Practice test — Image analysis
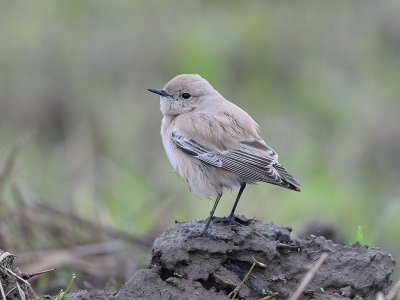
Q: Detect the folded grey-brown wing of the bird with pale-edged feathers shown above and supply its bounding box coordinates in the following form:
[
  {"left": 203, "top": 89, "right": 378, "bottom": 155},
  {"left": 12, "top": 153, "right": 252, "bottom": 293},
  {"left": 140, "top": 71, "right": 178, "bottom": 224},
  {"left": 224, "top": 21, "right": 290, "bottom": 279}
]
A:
[{"left": 171, "top": 130, "right": 300, "bottom": 190}]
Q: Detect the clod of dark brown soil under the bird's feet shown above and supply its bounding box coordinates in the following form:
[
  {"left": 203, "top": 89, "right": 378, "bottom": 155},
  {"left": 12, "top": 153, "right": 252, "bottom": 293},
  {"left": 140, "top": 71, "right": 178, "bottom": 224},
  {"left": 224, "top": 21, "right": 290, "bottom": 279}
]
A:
[{"left": 108, "top": 217, "right": 395, "bottom": 299}]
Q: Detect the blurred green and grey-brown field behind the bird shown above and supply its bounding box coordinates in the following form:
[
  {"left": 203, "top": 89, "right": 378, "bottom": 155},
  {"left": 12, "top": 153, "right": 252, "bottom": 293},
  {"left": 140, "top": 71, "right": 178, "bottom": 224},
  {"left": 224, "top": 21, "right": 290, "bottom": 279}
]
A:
[{"left": 0, "top": 0, "right": 400, "bottom": 288}]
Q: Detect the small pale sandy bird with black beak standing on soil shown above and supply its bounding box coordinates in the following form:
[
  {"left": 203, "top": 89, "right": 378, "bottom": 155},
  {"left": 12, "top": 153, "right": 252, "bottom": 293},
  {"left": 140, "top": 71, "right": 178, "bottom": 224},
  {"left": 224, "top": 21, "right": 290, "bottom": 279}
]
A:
[{"left": 148, "top": 74, "right": 300, "bottom": 234}]
